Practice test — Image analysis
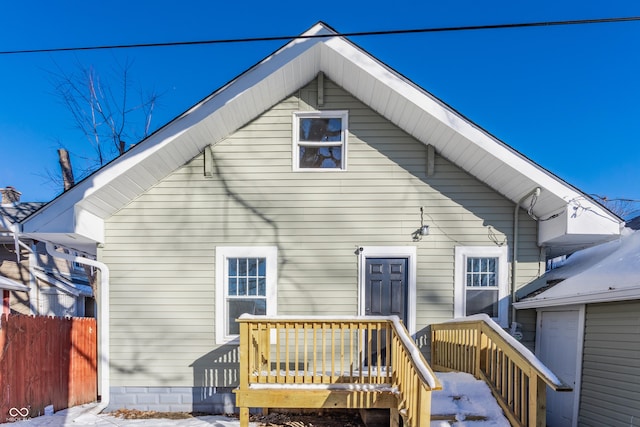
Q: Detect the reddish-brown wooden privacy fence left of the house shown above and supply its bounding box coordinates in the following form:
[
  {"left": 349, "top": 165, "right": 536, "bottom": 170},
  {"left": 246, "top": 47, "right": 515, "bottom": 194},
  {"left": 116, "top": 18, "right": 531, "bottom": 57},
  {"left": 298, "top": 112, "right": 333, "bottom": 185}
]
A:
[{"left": 0, "top": 315, "right": 98, "bottom": 423}]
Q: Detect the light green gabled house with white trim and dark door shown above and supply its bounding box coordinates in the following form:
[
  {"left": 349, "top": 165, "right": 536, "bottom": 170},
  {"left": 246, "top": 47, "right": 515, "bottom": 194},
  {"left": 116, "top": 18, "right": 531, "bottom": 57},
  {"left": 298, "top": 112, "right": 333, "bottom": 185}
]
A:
[{"left": 22, "top": 23, "right": 621, "bottom": 412}]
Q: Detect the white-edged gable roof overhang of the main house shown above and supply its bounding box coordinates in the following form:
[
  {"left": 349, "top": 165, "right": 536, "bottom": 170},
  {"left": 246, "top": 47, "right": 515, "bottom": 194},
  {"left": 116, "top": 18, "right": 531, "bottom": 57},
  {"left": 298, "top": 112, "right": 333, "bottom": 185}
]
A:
[{"left": 23, "top": 23, "right": 621, "bottom": 252}]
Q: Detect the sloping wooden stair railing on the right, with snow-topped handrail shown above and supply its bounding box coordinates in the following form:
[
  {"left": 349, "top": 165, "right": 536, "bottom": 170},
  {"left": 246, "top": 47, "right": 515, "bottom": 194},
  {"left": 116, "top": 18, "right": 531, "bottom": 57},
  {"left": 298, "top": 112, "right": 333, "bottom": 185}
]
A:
[{"left": 431, "top": 315, "right": 571, "bottom": 427}]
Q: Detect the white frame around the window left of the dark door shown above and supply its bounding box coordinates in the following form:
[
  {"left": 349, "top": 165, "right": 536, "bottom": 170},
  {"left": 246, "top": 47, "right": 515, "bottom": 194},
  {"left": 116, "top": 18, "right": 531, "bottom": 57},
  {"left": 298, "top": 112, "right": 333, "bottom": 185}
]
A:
[{"left": 215, "top": 246, "right": 278, "bottom": 344}]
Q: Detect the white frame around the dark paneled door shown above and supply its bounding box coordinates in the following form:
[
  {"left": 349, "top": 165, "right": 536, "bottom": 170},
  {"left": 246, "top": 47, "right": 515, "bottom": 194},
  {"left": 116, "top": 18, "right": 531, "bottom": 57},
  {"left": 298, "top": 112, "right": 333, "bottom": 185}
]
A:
[{"left": 358, "top": 246, "right": 417, "bottom": 335}]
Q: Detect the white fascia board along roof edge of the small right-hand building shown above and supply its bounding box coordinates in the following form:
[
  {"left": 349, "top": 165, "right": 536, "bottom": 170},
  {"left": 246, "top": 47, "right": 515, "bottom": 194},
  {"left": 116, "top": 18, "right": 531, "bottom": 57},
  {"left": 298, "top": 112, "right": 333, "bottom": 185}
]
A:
[{"left": 513, "top": 285, "right": 640, "bottom": 310}]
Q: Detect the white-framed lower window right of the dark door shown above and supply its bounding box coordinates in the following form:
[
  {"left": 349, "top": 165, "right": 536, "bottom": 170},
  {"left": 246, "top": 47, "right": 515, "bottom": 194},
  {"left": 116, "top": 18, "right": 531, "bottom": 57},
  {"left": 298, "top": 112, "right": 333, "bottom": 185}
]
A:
[{"left": 454, "top": 246, "right": 509, "bottom": 328}]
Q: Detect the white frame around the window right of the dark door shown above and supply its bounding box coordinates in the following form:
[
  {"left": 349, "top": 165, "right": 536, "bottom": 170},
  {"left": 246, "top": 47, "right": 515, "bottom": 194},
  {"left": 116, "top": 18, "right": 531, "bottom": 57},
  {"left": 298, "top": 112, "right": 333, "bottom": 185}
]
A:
[{"left": 453, "top": 246, "right": 509, "bottom": 328}]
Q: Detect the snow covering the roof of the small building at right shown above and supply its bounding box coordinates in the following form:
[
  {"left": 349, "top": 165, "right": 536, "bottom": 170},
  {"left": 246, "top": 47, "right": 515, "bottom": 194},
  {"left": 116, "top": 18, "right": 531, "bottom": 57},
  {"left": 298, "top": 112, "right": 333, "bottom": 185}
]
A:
[{"left": 514, "top": 228, "right": 640, "bottom": 309}]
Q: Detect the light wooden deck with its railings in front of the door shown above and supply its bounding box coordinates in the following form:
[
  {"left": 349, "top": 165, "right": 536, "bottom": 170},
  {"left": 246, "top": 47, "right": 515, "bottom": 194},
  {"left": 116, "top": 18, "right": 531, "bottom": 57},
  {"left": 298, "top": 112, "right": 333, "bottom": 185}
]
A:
[{"left": 235, "top": 315, "right": 571, "bottom": 427}]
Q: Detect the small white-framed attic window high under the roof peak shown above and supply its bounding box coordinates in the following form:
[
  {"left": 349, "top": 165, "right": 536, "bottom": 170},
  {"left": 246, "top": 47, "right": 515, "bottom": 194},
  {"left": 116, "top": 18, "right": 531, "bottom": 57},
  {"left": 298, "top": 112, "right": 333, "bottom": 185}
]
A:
[{"left": 292, "top": 111, "right": 349, "bottom": 171}]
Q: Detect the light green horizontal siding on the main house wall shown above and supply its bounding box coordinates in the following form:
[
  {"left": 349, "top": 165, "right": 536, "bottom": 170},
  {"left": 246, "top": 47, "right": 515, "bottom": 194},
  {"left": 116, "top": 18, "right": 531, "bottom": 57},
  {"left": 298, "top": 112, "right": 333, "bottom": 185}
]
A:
[{"left": 101, "top": 80, "right": 540, "bottom": 386}]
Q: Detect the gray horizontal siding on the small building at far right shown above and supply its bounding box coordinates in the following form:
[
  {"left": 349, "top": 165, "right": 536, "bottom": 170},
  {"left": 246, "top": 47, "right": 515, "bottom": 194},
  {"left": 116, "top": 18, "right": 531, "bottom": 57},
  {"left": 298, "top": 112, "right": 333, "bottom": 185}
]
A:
[{"left": 578, "top": 301, "right": 640, "bottom": 427}]
